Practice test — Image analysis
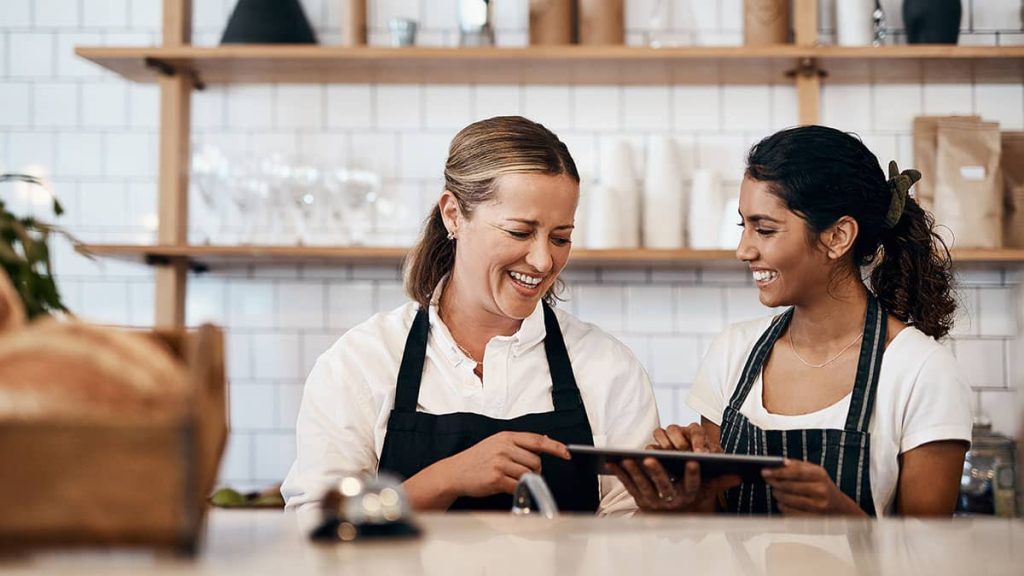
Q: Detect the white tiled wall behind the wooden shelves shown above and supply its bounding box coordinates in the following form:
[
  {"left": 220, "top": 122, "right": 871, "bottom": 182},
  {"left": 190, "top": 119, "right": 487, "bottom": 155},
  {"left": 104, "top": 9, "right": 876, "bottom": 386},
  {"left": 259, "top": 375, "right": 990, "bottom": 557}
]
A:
[{"left": 0, "top": 0, "right": 1024, "bottom": 486}]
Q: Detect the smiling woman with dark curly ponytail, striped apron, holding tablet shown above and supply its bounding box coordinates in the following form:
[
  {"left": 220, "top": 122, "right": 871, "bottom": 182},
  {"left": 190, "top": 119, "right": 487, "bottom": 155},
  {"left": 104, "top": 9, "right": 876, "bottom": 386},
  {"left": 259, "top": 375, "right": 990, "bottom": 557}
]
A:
[{"left": 618, "top": 126, "right": 971, "bottom": 517}]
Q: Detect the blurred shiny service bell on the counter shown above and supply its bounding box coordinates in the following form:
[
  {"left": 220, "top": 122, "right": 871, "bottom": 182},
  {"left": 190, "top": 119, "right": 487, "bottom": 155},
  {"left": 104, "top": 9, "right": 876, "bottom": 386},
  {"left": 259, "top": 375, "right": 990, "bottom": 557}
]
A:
[{"left": 309, "top": 474, "right": 420, "bottom": 542}]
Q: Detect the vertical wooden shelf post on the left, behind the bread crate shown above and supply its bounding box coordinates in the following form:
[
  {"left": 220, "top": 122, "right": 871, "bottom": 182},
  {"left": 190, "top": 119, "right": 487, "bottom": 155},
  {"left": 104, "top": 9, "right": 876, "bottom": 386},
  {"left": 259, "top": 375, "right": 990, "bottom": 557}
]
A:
[{"left": 154, "top": 0, "right": 191, "bottom": 328}]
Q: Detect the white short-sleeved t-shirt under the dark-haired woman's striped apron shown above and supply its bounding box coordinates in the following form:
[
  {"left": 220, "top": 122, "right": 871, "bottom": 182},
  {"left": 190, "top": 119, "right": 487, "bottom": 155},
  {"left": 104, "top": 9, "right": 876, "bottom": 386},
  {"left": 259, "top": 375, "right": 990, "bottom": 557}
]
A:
[{"left": 687, "top": 317, "right": 972, "bottom": 517}]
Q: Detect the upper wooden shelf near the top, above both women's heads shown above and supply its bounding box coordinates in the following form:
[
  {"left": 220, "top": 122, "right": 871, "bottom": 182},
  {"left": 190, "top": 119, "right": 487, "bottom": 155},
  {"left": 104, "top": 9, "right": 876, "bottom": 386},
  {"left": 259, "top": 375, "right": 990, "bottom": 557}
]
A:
[{"left": 75, "top": 45, "right": 1024, "bottom": 85}]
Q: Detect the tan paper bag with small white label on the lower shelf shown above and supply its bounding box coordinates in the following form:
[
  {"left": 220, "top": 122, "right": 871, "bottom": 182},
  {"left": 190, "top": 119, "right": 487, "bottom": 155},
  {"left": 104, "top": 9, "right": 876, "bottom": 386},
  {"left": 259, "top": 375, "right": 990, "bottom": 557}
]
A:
[{"left": 933, "top": 120, "right": 1002, "bottom": 248}]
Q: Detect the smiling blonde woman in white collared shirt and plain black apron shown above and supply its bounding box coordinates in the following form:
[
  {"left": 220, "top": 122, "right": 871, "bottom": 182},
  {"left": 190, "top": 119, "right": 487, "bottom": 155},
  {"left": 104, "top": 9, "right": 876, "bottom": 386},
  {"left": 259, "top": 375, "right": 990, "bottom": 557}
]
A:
[{"left": 282, "top": 117, "right": 658, "bottom": 513}]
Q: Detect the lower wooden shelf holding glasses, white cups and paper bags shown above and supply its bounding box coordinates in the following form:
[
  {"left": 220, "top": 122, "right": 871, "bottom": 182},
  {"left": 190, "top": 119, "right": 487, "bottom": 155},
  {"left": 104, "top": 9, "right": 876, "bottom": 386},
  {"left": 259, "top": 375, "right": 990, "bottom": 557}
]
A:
[{"left": 79, "top": 244, "right": 1024, "bottom": 271}]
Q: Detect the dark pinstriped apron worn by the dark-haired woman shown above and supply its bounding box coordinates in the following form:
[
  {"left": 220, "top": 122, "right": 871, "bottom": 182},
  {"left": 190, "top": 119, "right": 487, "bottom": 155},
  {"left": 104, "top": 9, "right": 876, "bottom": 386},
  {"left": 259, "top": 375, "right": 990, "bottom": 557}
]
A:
[{"left": 721, "top": 293, "right": 887, "bottom": 517}]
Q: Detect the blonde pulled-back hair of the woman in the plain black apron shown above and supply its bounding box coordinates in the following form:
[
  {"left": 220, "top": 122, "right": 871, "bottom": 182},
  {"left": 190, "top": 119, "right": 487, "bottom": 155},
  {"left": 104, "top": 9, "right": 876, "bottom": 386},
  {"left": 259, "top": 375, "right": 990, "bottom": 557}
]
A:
[{"left": 406, "top": 116, "right": 580, "bottom": 308}]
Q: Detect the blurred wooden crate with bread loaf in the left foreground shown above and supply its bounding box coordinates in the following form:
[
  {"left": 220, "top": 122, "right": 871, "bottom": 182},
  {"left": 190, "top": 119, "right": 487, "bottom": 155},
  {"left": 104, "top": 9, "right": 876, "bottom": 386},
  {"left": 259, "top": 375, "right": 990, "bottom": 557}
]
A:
[{"left": 0, "top": 320, "right": 227, "bottom": 553}]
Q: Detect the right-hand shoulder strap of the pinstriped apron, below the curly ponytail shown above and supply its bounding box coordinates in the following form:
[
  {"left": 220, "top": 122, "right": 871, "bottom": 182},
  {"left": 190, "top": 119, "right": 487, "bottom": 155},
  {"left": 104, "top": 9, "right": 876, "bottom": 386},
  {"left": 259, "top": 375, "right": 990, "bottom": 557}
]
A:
[{"left": 846, "top": 292, "right": 888, "bottom": 433}]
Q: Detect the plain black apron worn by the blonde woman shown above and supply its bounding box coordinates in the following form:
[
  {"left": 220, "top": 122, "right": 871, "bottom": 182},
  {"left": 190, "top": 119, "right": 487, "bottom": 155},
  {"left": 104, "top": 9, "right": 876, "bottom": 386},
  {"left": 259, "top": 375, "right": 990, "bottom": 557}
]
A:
[{"left": 379, "top": 303, "right": 599, "bottom": 512}]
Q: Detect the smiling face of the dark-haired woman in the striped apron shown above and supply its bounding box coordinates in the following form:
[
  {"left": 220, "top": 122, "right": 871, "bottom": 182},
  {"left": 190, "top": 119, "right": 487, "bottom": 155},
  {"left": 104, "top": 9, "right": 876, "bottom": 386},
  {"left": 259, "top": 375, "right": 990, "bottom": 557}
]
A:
[{"left": 736, "top": 177, "right": 835, "bottom": 307}]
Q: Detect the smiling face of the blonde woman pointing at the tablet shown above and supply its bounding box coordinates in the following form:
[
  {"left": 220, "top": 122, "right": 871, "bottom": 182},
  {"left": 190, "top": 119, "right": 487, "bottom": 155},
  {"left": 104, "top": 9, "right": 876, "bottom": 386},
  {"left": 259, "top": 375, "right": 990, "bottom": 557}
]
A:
[{"left": 441, "top": 173, "right": 580, "bottom": 321}]
